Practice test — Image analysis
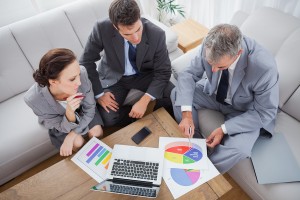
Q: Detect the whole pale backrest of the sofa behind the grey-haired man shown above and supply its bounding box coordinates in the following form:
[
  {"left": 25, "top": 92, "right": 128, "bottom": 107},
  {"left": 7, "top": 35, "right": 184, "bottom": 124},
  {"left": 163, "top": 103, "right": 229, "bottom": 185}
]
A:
[{"left": 237, "top": 7, "right": 300, "bottom": 120}]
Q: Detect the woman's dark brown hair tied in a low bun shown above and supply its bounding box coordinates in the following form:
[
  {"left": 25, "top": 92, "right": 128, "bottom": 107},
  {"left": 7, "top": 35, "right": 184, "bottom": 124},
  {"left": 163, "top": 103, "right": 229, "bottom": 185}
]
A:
[{"left": 33, "top": 48, "right": 76, "bottom": 87}]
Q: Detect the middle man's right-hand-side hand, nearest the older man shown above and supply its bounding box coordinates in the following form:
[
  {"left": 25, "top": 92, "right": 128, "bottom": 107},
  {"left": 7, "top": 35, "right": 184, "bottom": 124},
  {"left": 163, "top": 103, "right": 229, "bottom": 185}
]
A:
[{"left": 129, "top": 94, "right": 151, "bottom": 118}]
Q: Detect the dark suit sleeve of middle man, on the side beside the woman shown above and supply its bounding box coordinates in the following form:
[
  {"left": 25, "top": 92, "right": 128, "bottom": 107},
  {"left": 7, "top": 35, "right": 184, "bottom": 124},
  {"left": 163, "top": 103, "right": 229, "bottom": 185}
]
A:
[{"left": 79, "top": 23, "right": 103, "bottom": 95}]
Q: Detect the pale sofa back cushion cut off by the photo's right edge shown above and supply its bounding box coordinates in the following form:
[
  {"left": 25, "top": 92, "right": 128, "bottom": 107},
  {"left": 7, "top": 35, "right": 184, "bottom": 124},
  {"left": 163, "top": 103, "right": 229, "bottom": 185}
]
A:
[{"left": 276, "top": 28, "right": 300, "bottom": 120}]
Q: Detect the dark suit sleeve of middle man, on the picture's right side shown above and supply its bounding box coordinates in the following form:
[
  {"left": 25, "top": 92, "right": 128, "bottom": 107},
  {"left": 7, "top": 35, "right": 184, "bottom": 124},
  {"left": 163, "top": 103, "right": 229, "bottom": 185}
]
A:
[{"left": 147, "top": 32, "right": 171, "bottom": 98}]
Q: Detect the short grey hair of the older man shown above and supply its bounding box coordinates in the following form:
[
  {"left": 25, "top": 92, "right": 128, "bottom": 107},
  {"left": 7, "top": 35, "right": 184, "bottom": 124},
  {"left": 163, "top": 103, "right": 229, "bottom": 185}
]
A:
[{"left": 203, "top": 24, "right": 243, "bottom": 63}]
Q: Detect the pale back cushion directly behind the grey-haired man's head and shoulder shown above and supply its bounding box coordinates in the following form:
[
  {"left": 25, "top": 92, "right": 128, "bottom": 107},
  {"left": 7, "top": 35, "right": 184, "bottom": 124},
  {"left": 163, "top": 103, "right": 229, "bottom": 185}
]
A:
[{"left": 240, "top": 7, "right": 300, "bottom": 55}]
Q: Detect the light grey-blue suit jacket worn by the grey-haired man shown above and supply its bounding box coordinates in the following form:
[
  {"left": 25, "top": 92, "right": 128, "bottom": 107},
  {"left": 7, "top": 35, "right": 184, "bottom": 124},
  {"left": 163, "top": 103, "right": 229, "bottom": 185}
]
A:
[{"left": 175, "top": 36, "right": 279, "bottom": 134}]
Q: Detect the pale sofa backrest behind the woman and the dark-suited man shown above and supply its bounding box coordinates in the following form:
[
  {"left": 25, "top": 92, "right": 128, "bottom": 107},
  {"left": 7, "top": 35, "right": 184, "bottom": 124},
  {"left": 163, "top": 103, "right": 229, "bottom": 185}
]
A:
[{"left": 0, "top": 0, "right": 178, "bottom": 102}]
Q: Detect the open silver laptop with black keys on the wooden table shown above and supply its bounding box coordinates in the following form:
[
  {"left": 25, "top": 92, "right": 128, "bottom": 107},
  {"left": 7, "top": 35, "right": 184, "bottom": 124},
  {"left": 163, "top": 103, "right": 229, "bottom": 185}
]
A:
[{"left": 91, "top": 144, "right": 164, "bottom": 198}]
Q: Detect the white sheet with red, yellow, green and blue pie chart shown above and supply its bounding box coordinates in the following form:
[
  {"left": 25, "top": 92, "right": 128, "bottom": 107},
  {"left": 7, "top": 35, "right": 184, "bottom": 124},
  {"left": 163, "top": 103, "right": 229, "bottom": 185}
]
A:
[{"left": 159, "top": 137, "right": 208, "bottom": 169}]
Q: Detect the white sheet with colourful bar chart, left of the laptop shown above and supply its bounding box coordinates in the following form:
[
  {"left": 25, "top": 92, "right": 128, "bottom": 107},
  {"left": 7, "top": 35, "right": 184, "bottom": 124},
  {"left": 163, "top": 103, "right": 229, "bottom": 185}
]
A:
[{"left": 72, "top": 137, "right": 112, "bottom": 183}]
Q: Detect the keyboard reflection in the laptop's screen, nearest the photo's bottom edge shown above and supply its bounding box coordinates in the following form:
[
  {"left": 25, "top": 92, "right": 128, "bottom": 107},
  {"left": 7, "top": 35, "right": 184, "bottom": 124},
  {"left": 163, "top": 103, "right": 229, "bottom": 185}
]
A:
[{"left": 110, "top": 184, "right": 156, "bottom": 197}]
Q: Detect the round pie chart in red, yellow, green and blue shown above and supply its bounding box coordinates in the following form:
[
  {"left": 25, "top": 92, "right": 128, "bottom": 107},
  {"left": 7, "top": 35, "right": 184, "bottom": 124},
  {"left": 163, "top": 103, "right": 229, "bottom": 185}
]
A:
[{"left": 164, "top": 142, "right": 203, "bottom": 164}]
